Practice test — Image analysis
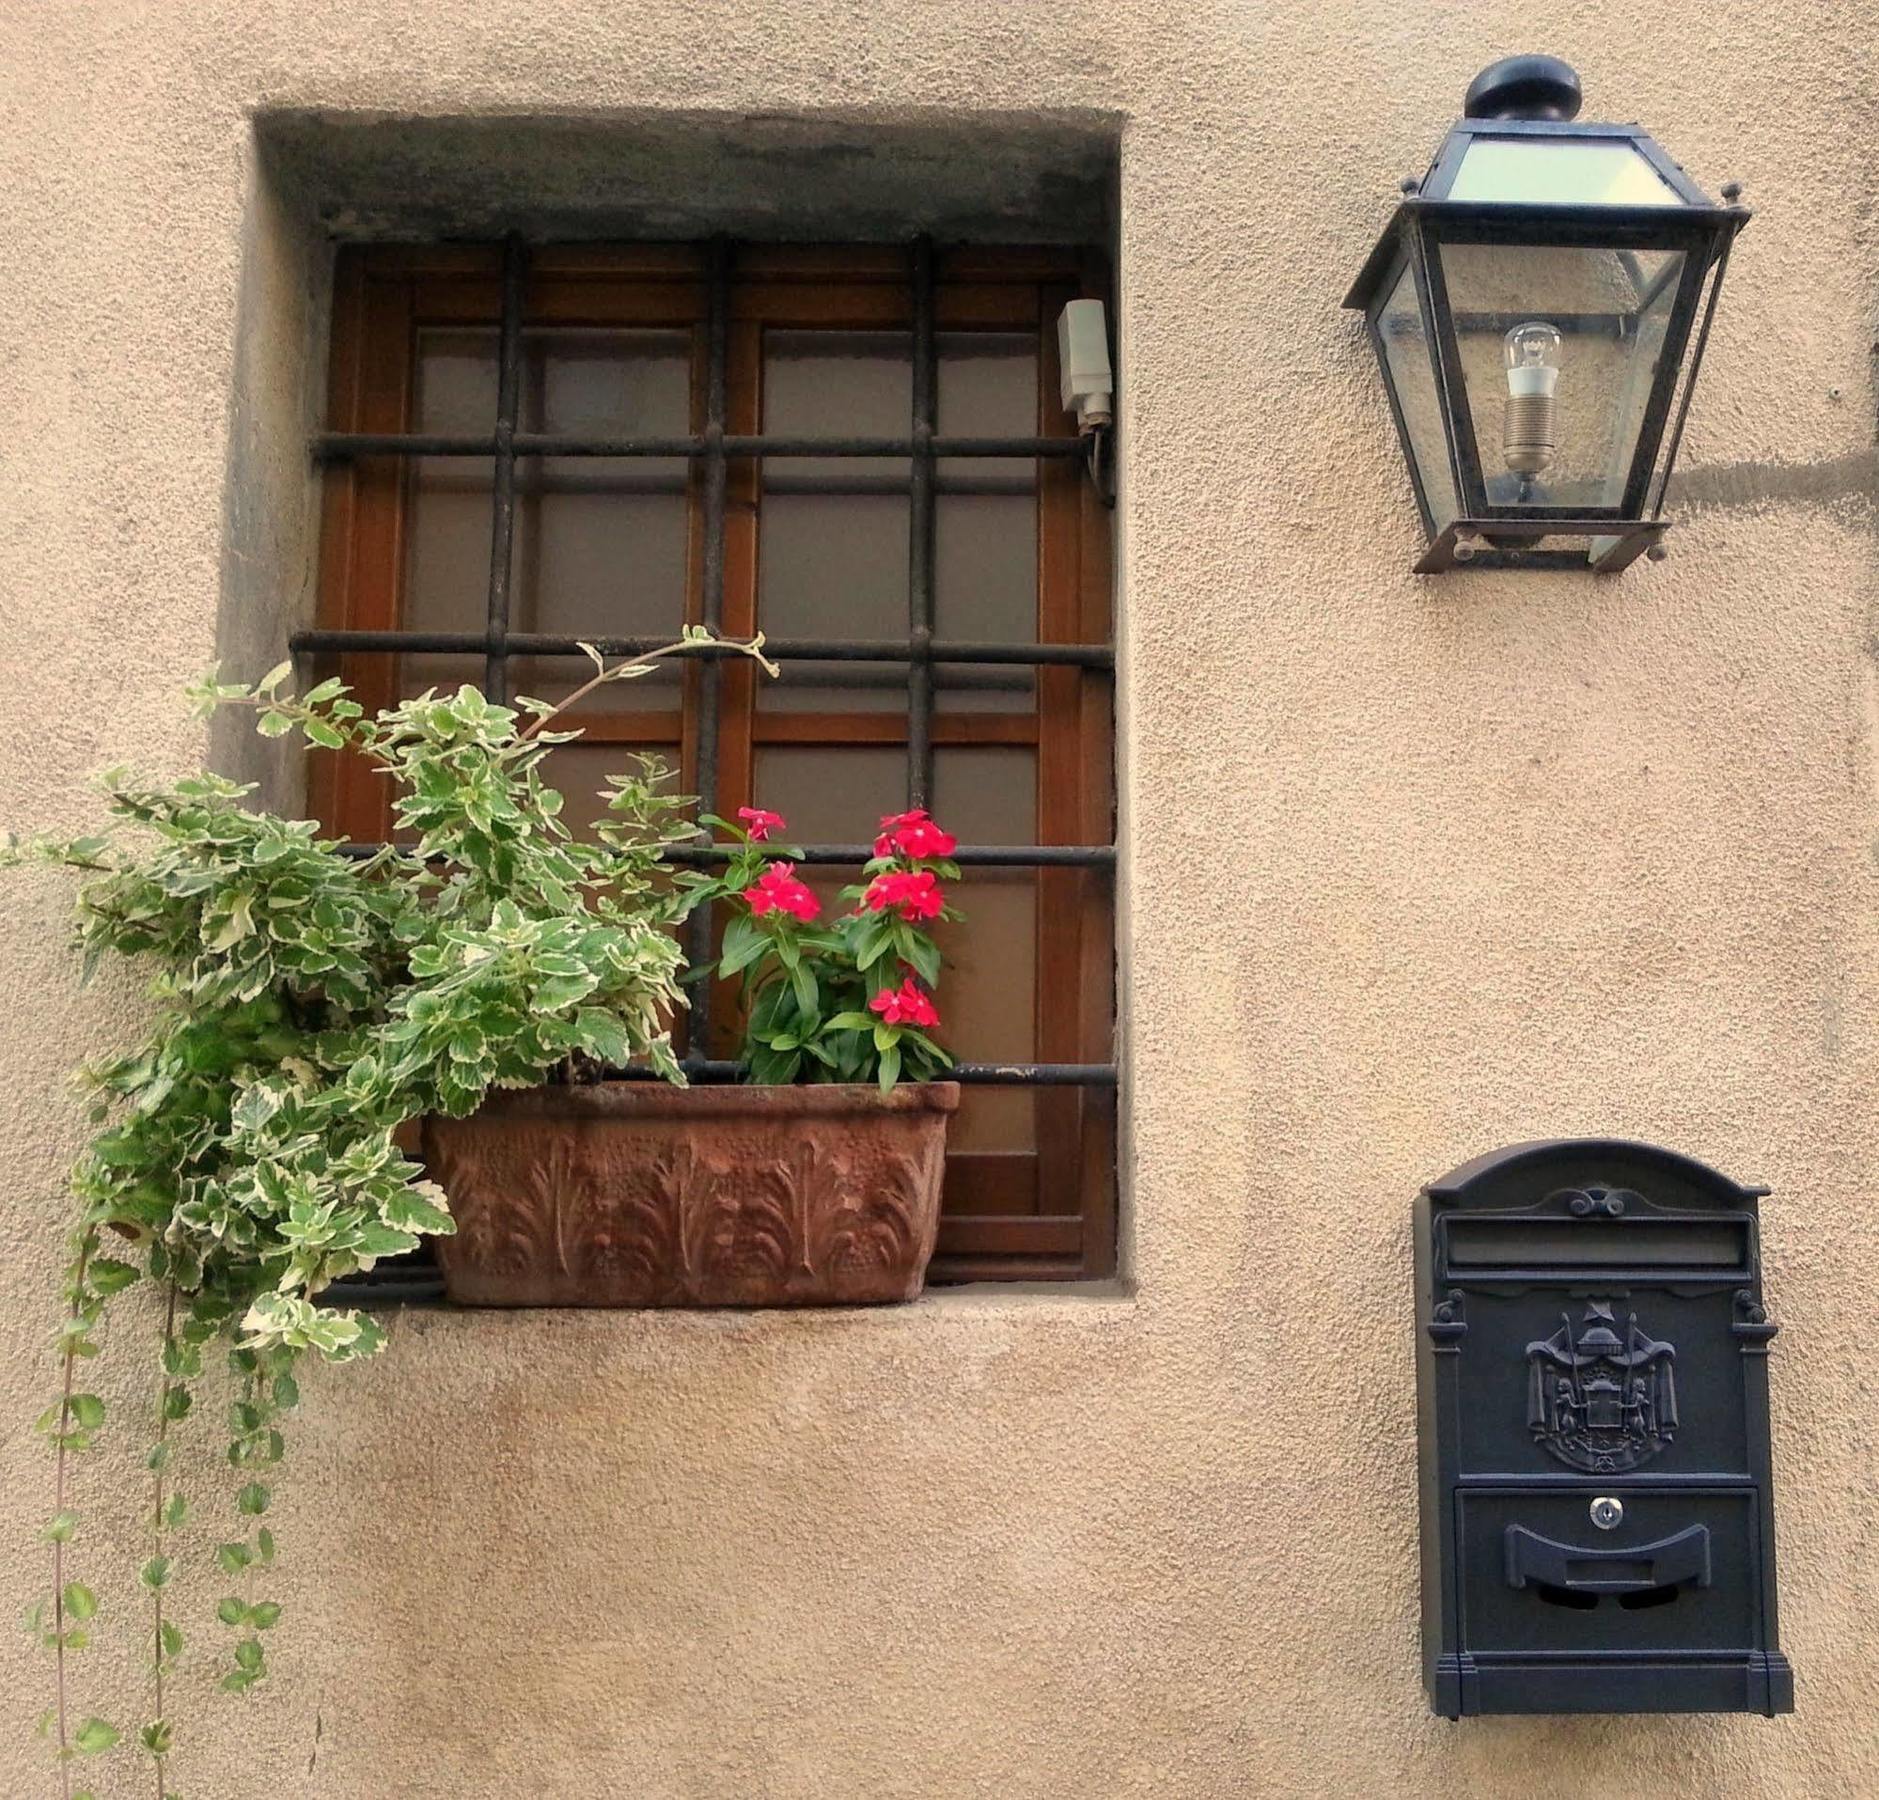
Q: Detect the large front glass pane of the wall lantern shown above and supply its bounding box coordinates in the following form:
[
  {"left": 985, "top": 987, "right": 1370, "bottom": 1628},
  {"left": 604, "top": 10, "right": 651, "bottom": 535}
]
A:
[{"left": 1439, "top": 242, "right": 1684, "bottom": 511}]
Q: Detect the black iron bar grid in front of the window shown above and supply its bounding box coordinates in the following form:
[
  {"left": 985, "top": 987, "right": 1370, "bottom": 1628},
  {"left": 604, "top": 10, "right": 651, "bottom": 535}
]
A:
[{"left": 291, "top": 235, "right": 1116, "bottom": 1142}]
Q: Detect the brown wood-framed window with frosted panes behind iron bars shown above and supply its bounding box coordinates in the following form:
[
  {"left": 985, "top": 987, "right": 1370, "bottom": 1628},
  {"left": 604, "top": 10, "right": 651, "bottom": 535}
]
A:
[{"left": 293, "top": 239, "right": 1114, "bottom": 1281}]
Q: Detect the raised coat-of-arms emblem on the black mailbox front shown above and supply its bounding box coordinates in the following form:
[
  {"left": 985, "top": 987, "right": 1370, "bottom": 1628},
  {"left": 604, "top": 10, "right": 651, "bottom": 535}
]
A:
[{"left": 1526, "top": 1300, "right": 1676, "bottom": 1475}]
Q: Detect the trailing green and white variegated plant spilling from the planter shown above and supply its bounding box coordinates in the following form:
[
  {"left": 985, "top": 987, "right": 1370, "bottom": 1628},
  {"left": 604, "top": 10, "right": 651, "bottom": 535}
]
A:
[{"left": 6, "top": 629, "right": 774, "bottom": 1800}]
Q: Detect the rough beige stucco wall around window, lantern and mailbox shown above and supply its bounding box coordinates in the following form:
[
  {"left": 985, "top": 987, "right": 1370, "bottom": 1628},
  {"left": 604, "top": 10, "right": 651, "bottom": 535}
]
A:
[{"left": 0, "top": 0, "right": 1879, "bottom": 1800}]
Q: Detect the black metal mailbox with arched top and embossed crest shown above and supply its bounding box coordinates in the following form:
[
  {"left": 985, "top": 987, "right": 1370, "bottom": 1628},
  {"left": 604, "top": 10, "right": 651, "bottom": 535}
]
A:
[{"left": 1415, "top": 1139, "right": 1794, "bottom": 1719}]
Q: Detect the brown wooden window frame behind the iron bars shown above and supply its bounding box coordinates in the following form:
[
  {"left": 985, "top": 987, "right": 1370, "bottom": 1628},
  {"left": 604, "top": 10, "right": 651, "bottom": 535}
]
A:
[{"left": 295, "top": 242, "right": 1116, "bottom": 1281}]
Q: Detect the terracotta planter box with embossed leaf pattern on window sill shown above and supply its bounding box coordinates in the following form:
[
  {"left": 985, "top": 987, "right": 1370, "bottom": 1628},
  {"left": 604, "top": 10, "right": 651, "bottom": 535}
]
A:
[{"left": 425, "top": 1082, "right": 958, "bottom": 1306}]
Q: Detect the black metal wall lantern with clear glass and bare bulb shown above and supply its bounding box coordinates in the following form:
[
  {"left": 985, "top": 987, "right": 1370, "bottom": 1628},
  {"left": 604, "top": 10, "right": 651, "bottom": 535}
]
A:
[{"left": 1343, "top": 56, "right": 1749, "bottom": 575}]
